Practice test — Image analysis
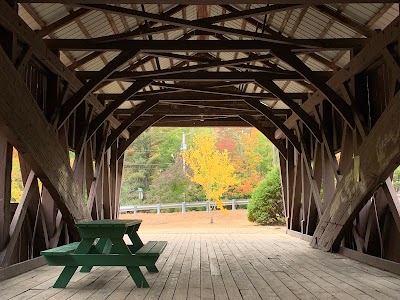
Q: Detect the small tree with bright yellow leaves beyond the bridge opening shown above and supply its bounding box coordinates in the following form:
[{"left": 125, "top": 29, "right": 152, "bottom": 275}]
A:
[{"left": 183, "top": 133, "right": 238, "bottom": 217}]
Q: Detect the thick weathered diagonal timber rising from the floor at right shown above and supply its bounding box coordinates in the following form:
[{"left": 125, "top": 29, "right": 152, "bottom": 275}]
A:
[{"left": 312, "top": 92, "right": 400, "bottom": 251}]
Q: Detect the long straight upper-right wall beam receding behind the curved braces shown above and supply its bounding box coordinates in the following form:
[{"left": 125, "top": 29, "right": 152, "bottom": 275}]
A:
[{"left": 275, "top": 17, "right": 400, "bottom": 138}]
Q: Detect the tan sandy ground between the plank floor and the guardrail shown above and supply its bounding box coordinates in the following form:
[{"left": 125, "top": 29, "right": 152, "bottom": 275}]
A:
[{"left": 119, "top": 209, "right": 285, "bottom": 234}]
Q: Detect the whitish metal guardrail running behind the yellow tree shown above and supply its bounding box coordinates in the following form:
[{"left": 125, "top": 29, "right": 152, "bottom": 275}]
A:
[{"left": 119, "top": 199, "right": 249, "bottom": 214}]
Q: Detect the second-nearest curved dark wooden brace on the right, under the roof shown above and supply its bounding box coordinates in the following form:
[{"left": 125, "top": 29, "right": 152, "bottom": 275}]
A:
[{"left": 257, "top": 79, "right": 322, "bottom": 142}]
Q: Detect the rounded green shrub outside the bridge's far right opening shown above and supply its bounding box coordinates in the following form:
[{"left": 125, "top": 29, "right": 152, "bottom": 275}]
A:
[{"left": 247, "top": 168, "right": 285, "bottom": 225}]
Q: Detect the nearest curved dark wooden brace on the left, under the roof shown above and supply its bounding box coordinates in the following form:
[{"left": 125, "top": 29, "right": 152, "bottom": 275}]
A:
[{"left": 58, "top": 49, "right": 139, "bottom": 127}]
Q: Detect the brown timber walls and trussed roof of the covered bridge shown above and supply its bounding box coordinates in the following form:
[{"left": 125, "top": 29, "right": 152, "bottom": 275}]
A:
[{"left": 0, "top": 0, "right": 400, "bottom": 299}]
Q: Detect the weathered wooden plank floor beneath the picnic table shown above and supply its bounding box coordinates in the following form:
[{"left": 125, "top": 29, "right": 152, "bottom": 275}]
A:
[{"left": 0, "top": 234, "right": 400, "bottom": 300}]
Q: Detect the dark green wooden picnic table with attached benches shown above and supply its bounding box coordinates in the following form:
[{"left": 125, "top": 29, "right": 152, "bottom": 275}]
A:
[{"left": 40, "top": 220, "right": 167, "bottom": 288}]
